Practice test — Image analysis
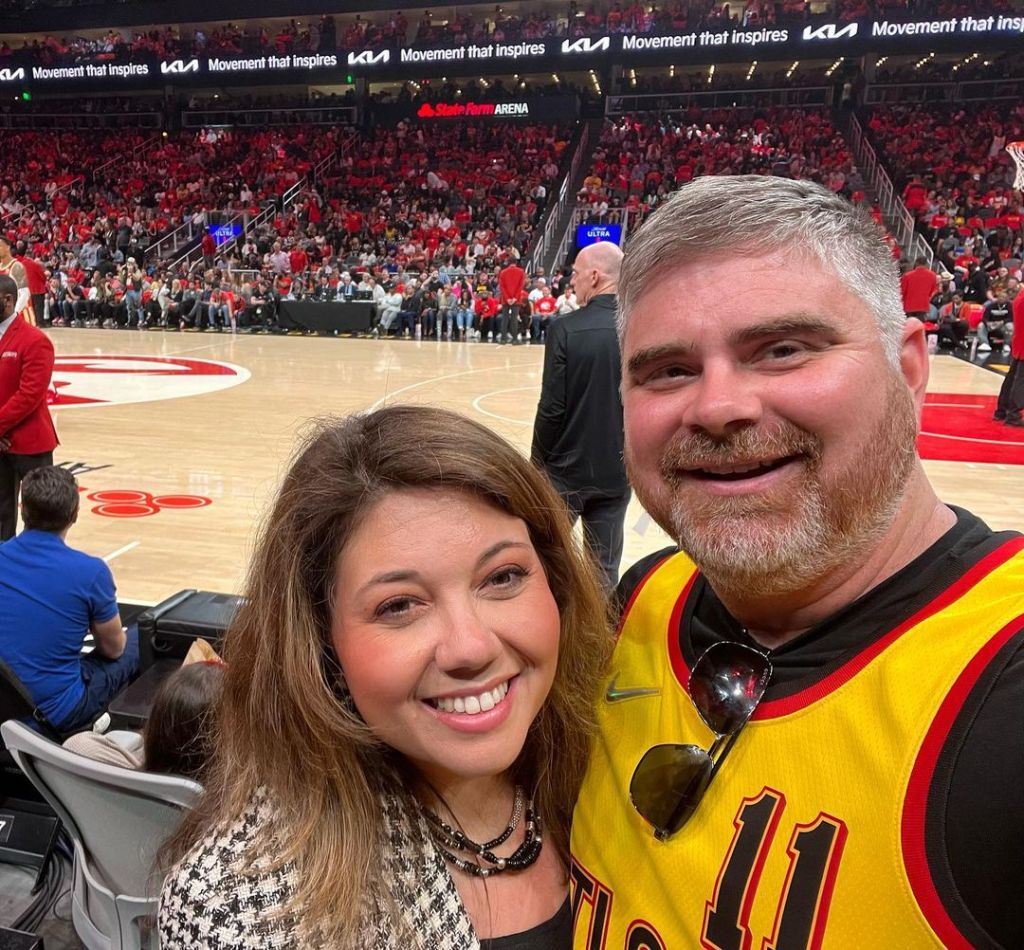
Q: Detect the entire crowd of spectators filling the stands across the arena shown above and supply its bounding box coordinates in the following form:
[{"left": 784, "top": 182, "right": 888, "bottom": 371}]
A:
[{"left": 6, "top": 97, "right": 1024, "bottom": 346}]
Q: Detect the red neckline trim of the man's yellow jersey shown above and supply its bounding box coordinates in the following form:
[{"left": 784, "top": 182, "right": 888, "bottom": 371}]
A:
[{"left": 669, "top": 537, "right": 1024, "bottom": 721}]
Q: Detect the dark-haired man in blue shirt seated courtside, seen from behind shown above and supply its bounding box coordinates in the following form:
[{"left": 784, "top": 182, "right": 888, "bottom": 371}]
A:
[{"left": 0, "top": 465, "right": 138, "bottom": 731}]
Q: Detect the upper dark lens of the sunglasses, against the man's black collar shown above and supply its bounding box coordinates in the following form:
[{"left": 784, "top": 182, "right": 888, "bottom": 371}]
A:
[{"left": 689, "top": 642, "right": 771, "bottom": 736}]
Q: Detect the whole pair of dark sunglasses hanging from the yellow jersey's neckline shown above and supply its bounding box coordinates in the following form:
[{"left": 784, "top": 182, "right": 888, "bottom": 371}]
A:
[{"left": 630, "top": 641, "right": 772, "bottom": 841}]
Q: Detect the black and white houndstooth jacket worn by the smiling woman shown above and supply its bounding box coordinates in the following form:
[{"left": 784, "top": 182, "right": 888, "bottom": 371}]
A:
[{"left": 159, "top": 793, "right": 480, "bottom": 950}]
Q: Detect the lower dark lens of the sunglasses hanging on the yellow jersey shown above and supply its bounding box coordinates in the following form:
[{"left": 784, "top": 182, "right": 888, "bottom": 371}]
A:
[{"left": 630, "top": 745, "right": 712, "bottom": 838}]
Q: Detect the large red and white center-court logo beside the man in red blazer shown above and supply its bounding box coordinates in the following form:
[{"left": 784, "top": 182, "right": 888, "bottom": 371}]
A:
[{"left": 51, "top": 354, "right": 250, "bottom": 409}]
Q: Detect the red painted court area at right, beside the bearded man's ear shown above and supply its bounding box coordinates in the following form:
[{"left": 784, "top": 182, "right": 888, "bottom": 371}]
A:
[{"left": 918, "top": 392, "right": 1024, "bottom": 465}]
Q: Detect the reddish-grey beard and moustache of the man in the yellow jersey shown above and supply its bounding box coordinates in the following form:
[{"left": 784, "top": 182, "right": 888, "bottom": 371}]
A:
[{"left": 631, "top": 380, "right": 918, "bottom": 597}]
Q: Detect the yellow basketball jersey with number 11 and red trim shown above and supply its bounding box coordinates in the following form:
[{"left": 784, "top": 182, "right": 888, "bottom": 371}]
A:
[{"left": 571, "top": 537, "right": 1024, "bottom": 950}]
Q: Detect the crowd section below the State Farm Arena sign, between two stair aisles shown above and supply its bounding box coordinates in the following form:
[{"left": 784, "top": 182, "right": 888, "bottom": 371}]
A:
[{"left": 288, "top": 122, "right": 571, "bottom": 270}]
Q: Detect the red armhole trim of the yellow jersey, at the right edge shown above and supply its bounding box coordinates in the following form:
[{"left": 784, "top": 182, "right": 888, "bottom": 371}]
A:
[{"left": 900, "top": 617, "right": 1024, "bottom": 950}]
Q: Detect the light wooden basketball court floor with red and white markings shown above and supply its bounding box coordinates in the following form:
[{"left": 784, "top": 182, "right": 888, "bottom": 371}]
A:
[{"left": 49, "top": 330, "right": 1024, "bottom": 603}]
